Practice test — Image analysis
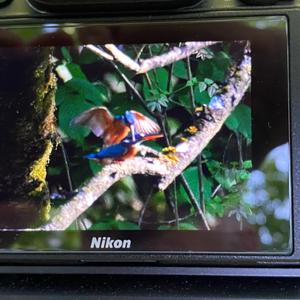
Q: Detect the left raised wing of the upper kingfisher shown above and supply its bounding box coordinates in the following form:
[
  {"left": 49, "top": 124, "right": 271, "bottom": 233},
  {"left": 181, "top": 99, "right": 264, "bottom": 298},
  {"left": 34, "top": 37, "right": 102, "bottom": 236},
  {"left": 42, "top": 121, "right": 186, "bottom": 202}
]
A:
[{"left": 71, "top": 106, "right": 114, "bottom": 137}]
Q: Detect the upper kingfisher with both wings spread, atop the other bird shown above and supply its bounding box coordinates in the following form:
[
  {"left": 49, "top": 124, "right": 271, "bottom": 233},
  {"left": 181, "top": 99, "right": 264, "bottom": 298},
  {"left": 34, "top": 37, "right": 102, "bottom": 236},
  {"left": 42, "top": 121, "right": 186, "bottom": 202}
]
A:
[{"left": 71, "top": 106, "right": 160, "bottom": 146}]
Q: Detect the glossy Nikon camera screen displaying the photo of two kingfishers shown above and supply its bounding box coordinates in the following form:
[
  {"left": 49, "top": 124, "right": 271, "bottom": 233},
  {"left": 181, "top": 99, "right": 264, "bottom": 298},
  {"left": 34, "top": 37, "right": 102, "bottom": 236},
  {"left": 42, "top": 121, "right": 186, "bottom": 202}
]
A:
[{"left": 0, "top": 17, "right": 292, "bottom": 254}]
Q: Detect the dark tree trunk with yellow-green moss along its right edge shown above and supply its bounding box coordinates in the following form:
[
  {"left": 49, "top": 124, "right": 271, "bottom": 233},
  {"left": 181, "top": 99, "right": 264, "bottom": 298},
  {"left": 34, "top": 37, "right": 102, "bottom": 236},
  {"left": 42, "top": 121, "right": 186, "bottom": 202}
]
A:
[{"left": 0, "top": 47, "right": 56, "bottom": 227}]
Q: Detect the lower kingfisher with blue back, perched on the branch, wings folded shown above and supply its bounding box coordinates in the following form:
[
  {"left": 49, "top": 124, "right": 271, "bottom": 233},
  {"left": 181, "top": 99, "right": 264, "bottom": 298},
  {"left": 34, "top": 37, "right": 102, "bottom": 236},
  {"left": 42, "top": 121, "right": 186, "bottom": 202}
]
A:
[{"left": 84, "top": 134, "right": 162, "bottom": 164}]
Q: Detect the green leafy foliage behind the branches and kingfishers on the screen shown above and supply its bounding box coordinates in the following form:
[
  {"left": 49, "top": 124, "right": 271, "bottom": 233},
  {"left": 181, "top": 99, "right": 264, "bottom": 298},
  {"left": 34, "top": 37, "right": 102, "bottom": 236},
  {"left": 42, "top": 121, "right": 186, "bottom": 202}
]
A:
[{"left": 48, "top": 43, "right": 252, "bottom": 230}]
